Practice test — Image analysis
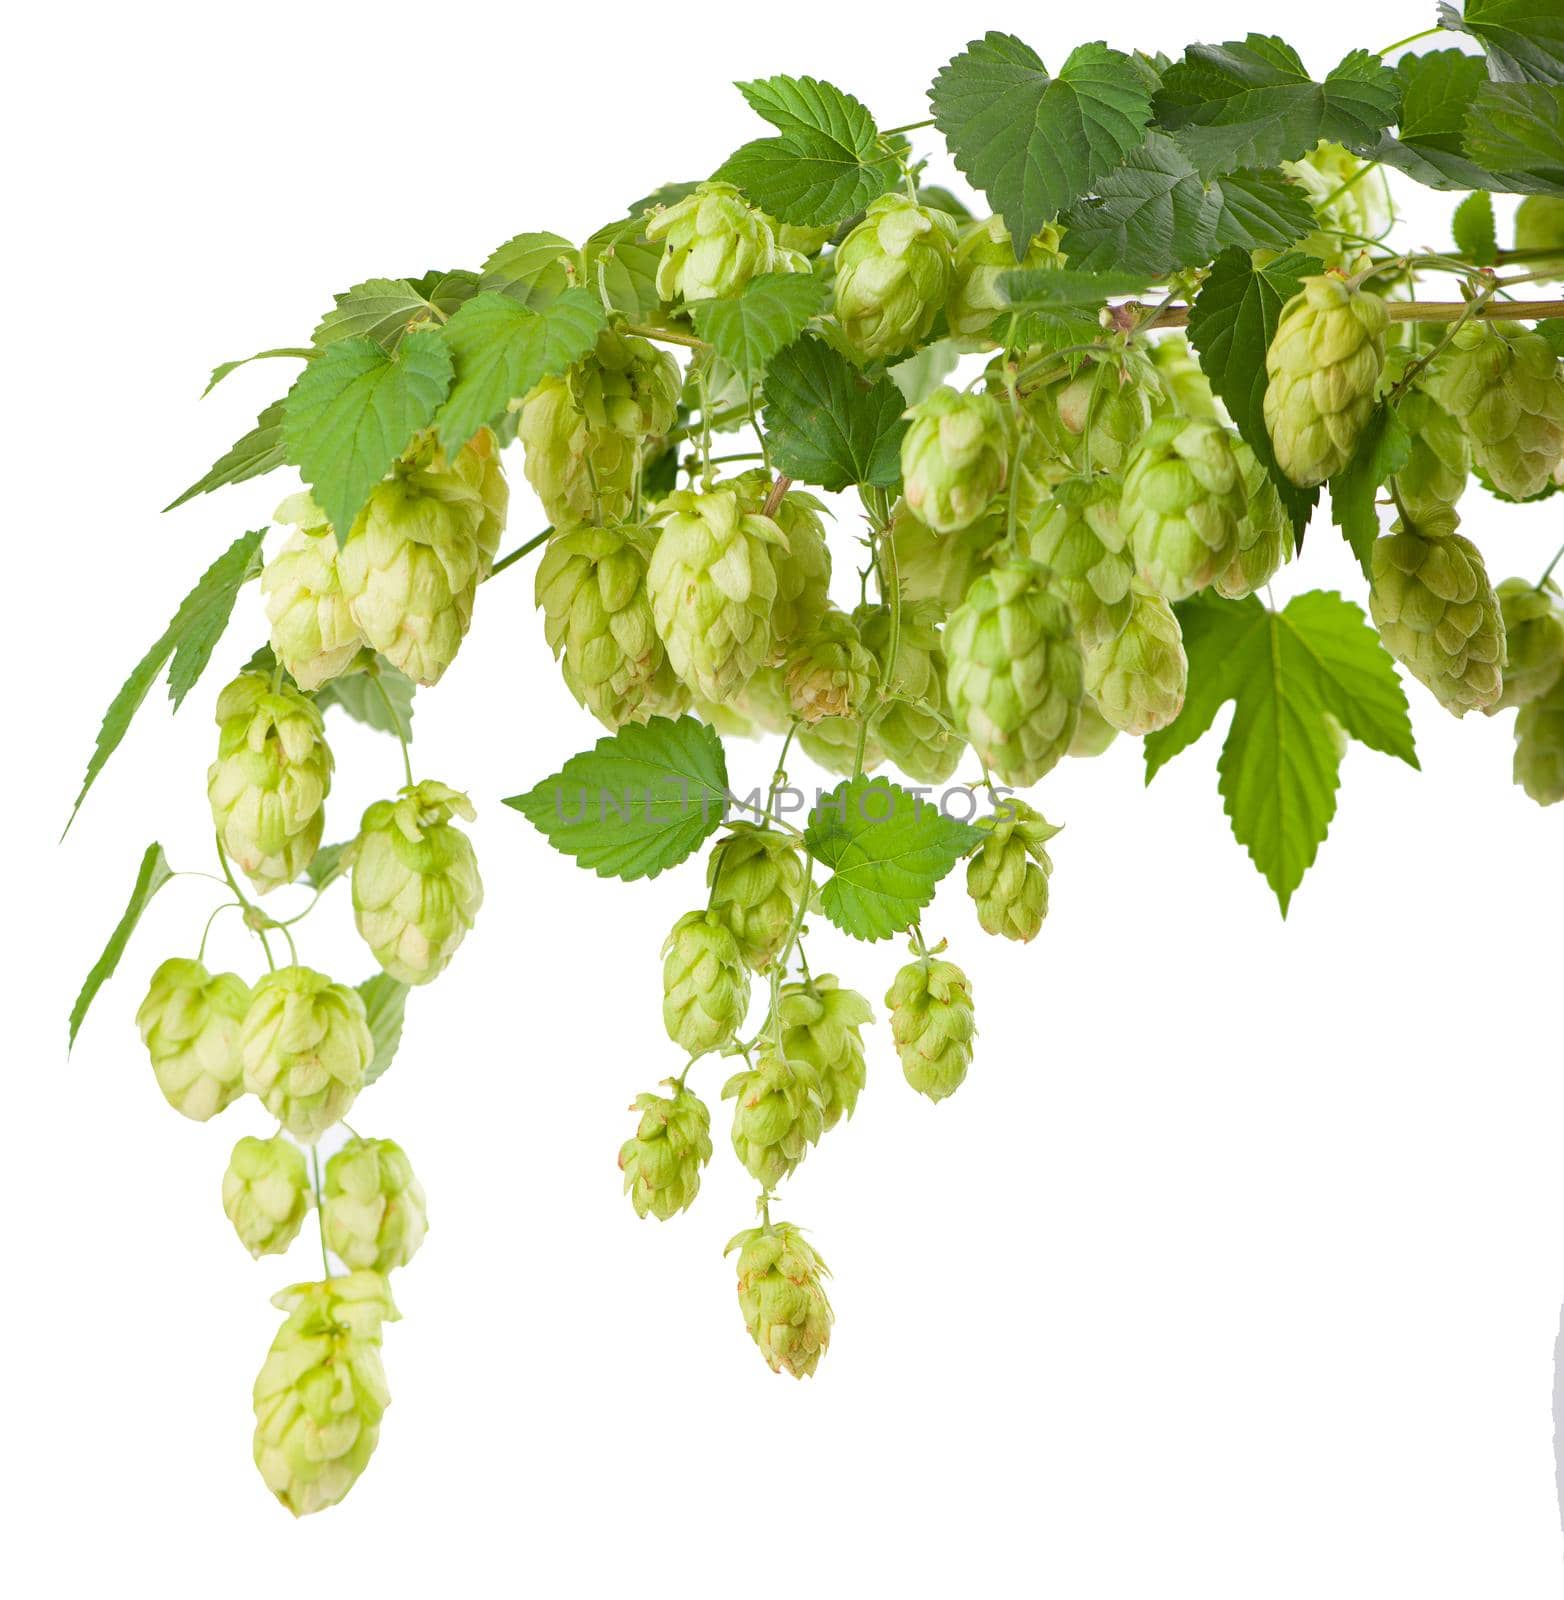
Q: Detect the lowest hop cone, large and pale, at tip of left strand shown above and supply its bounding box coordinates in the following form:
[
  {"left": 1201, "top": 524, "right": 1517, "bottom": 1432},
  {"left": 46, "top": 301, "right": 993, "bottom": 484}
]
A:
[{"left": 253, "top": 1272, "right": 398, "bottom": 1517}]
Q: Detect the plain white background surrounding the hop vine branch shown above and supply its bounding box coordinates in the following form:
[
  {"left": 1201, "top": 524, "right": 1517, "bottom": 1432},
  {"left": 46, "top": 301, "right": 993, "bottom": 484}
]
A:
[{"left": 0, "top": 0, "right": 1564, "bottom": 1600}]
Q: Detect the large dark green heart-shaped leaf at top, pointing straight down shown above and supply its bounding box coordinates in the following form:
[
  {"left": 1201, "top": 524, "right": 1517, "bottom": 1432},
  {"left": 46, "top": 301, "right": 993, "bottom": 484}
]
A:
[{"left": 929, "top": 32, "right": 1151, "bottom": 261}]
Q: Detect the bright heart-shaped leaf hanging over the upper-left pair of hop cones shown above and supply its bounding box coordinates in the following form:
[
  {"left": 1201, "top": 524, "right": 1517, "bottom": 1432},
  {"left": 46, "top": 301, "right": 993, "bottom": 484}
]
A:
[{"left": 283, "top": 331, "right": 454, "bottom": 542}]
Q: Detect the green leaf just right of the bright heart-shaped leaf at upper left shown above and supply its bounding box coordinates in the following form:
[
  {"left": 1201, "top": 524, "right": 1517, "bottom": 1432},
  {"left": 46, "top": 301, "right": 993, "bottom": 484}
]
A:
[{"left": 435, "top": 288, "right": 606, "bottom": 450}]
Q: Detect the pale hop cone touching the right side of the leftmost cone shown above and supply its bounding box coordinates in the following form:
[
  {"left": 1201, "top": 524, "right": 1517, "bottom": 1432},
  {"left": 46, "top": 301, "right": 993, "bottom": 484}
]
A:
[{"left": 238, "top": 966, "right": 374, "bottom": 1144}]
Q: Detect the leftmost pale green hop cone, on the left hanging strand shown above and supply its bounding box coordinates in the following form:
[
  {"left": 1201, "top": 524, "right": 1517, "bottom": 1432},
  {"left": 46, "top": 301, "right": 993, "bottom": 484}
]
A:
[{"left": 136, "top": 955, "right": 249, "bottom": 1122}]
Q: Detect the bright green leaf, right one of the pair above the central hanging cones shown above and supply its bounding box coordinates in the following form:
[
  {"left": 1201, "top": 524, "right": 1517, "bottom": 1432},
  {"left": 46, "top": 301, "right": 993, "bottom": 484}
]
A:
[{"left": 804, "top": 778, "right": 983, "bottom": 939}]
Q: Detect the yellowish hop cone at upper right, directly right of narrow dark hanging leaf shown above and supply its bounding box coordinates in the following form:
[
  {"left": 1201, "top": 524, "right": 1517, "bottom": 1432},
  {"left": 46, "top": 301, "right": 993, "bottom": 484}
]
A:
[{"left": 1265, "top": 274, "right": 1390, "bottom": 488}]
